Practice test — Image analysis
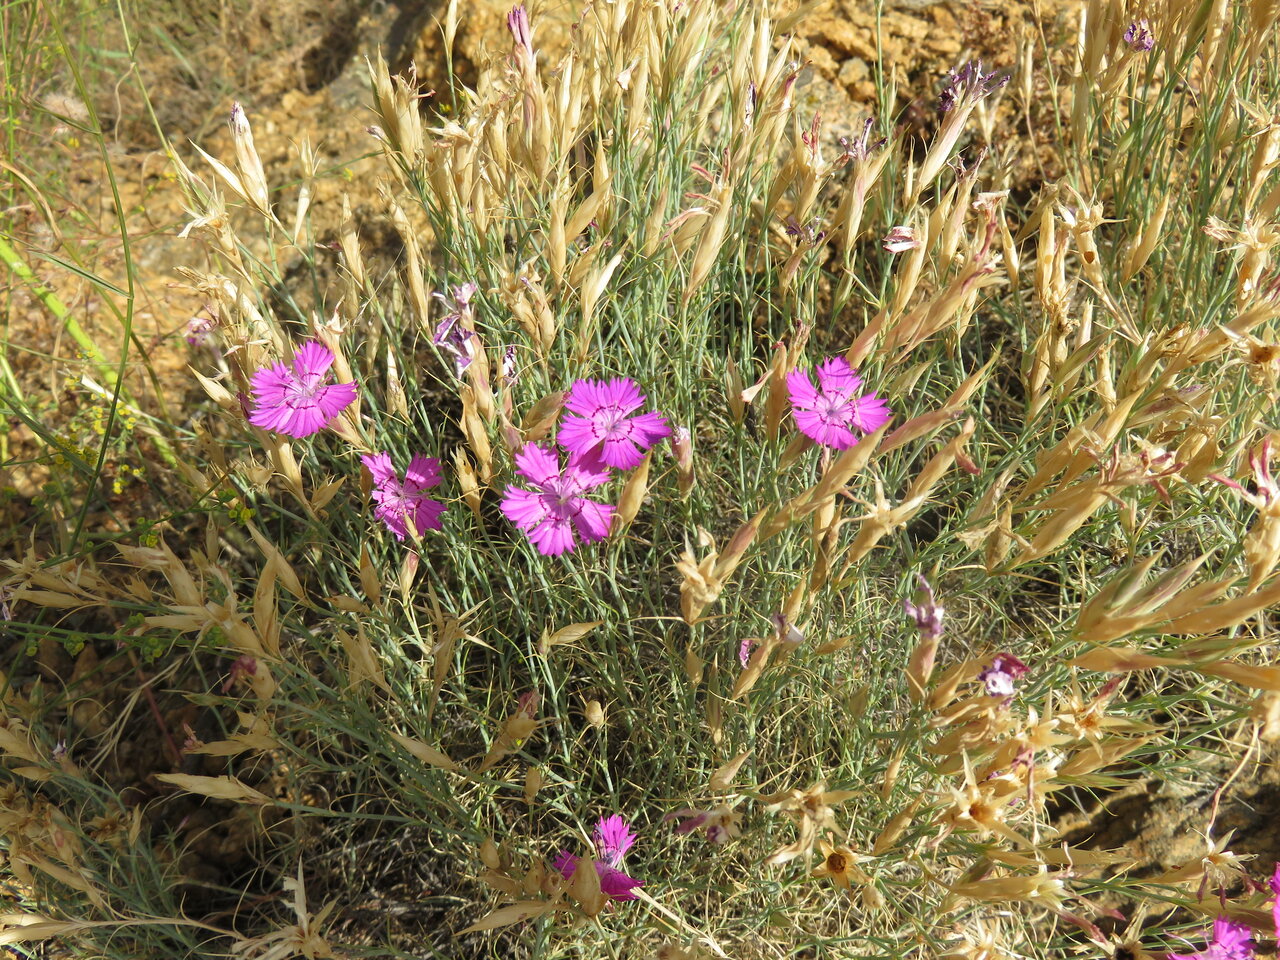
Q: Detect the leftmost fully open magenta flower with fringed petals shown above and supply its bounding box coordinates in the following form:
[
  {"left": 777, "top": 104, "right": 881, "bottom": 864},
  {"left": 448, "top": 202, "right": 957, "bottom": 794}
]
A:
[{"left": 248, "top": 340, "right": 356, "bottom": 439}]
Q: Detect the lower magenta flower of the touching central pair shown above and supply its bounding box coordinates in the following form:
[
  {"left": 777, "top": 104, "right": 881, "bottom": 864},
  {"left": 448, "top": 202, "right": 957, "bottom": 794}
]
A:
[{"left": 502, "top": 443, "right": 613, "bottom": 557}]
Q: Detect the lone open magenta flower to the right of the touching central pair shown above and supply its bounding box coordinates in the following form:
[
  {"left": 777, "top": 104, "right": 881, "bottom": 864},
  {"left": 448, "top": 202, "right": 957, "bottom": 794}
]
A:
[{"left": 787, "top": 357, "right": 890, "bottom": 451}]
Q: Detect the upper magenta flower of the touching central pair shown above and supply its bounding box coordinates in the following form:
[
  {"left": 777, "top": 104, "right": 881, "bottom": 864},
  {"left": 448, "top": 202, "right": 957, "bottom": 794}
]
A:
[{"left": 557, "top": 376, "right": 671, "bottom": 470}]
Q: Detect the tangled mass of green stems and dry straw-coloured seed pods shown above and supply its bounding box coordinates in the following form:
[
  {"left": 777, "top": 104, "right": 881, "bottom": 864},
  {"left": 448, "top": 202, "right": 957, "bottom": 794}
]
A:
[{"left": 0, "top": 0, "right": 1280, "bottom": 960}]
